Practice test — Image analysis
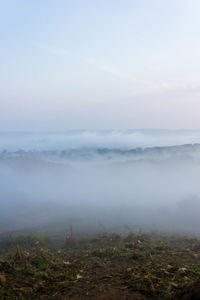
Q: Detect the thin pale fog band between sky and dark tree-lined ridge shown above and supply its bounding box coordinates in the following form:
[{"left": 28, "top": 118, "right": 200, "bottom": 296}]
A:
[{"left": 0, "top": 129, "right": 200, "bottom": 151}]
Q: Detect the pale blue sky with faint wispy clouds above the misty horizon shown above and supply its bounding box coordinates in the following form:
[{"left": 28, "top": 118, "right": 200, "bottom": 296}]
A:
[{"left": 0, "top": 0, "right": 200, "bottom": 131}]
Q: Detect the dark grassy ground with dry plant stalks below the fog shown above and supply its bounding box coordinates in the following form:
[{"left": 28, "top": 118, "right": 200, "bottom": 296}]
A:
[{"left": 0, "top": 233, "right": 200, "bottom": 300}]
